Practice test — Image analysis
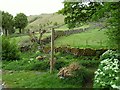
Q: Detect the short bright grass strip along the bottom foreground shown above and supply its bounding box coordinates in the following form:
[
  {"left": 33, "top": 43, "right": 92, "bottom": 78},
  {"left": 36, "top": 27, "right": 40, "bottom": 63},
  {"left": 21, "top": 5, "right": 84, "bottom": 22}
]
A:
[{"left": 3, "top": 71, "right": 81, "bottom": 88}]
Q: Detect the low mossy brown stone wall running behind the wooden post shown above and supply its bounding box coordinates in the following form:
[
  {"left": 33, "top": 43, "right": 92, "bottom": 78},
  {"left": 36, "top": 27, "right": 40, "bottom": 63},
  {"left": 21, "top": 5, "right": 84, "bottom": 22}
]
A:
[{"left": 42, "top": 47, "right": 115, "bottom": 56}]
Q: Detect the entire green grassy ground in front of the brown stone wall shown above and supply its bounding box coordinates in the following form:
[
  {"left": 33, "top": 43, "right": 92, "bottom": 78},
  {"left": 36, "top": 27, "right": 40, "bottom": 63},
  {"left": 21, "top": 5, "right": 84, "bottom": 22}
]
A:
[{"left": 2, "top": 52, "right": 100, "bottom": 88}]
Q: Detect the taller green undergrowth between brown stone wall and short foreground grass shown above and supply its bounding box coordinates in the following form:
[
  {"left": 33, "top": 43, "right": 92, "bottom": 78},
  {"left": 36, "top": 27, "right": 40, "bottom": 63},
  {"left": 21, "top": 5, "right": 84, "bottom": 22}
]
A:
[{"left": 2, "top": 51, "right": 100, "bottom": 71}]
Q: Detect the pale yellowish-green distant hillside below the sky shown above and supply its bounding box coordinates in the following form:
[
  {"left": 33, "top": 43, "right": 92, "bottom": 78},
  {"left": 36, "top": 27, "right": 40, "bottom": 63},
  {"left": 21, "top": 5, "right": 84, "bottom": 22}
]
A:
[{"left": 26, "top": 13, "right": 64, "bottom": 29}]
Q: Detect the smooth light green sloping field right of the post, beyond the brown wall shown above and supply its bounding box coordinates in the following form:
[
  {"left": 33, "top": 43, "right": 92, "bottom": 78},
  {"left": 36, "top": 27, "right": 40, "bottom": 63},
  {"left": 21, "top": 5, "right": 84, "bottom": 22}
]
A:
[{"left": 55, "top": 29, "right": 109, "bottom": 48}]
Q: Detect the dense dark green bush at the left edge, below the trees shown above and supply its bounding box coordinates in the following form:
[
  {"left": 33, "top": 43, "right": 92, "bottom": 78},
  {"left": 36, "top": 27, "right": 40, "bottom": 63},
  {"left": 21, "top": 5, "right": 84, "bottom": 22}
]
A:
[{"left": 2, "top": 36, "right": 20, "bottom": 61}]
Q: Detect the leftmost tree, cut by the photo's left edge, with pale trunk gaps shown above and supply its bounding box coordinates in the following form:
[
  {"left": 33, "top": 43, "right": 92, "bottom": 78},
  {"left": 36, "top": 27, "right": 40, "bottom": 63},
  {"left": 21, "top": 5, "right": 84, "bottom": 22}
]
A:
[{"left": 2, "top": 11, "right": 14, "bottom": 36}]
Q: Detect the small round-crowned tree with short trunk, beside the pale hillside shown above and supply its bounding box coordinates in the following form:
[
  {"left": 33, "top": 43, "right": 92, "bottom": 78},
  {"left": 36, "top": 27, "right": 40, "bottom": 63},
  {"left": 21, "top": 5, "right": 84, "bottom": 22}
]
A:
[{"left": 14, "top": 13, "right": 28, "bottom": 33}]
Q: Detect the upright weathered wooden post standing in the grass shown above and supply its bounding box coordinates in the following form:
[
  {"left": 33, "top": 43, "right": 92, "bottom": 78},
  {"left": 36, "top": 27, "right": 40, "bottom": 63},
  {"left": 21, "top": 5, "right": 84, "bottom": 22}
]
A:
[{"left": 50, "top": 28, "right": 54, "bottom": 73}]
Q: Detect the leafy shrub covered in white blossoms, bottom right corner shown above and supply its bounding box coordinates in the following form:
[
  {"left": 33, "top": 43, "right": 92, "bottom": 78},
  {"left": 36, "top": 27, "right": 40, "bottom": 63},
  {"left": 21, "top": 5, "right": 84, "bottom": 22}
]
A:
[{"left": 94, "top": 50, "right": 120, "bottom": 88}]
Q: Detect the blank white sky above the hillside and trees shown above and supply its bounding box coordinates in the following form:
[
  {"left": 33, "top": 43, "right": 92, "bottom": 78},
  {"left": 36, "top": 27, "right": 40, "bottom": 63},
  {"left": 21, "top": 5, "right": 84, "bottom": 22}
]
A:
[{"left": 0, "top": 0, "right": 64, "bottom": 16}]
